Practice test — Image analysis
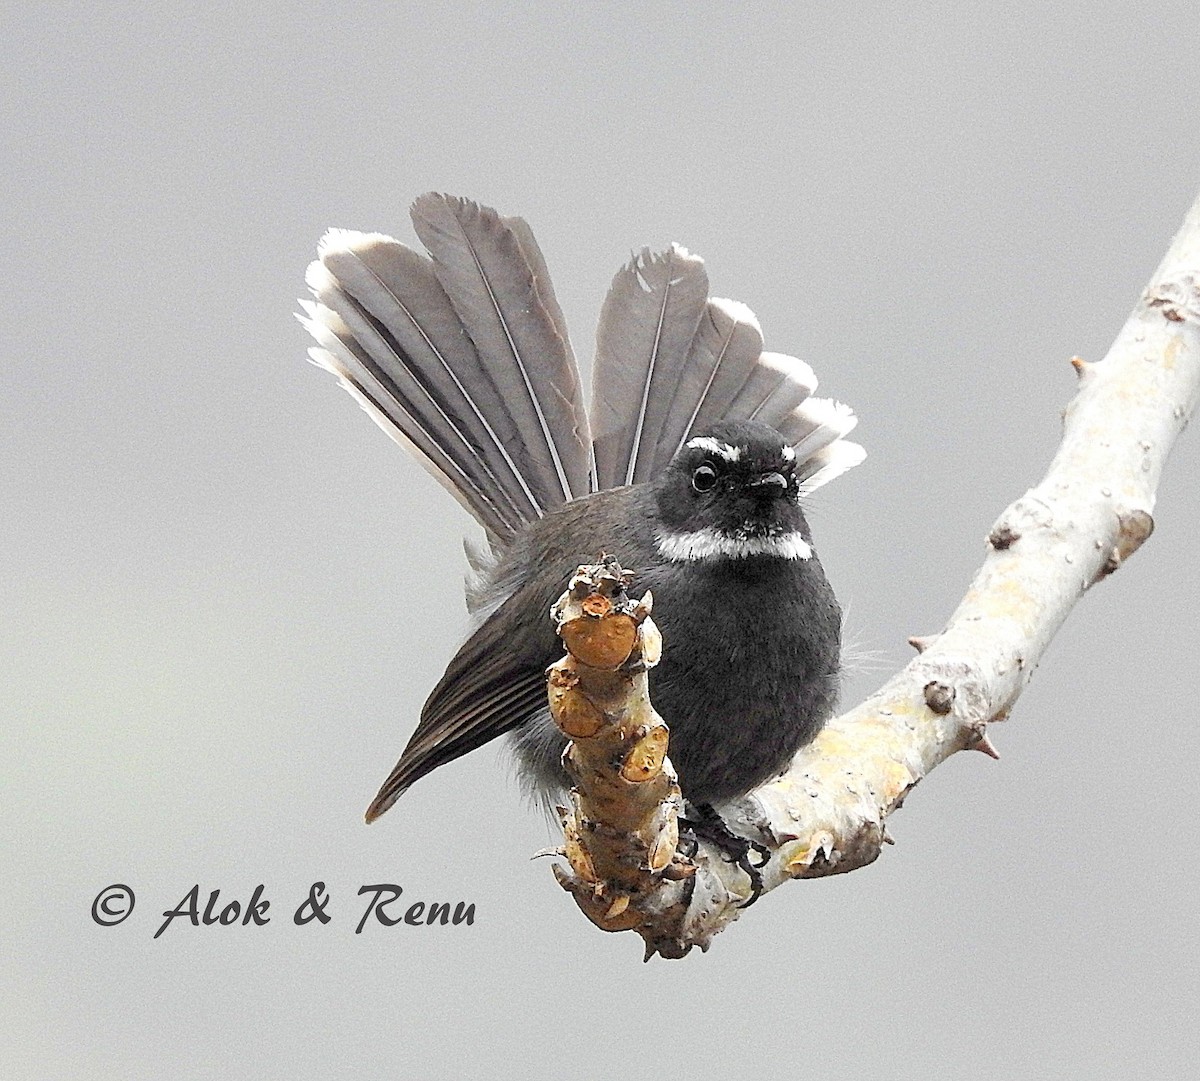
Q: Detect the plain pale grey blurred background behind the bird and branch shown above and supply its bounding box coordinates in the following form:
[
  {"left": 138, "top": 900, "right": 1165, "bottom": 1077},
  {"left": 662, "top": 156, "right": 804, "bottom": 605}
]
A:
[{"left": 0, "top": 0, "right": 1200, "bottom": 1081}]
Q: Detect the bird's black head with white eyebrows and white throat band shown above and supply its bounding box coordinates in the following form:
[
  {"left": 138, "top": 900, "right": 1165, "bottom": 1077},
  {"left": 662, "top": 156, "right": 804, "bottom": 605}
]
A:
[{"left": 655, "top": 421, "right": 812, "bottom": 563}]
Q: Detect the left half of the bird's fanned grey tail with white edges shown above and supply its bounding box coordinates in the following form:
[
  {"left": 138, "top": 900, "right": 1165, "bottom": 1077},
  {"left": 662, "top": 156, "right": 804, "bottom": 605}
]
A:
[{"left": 301, "top": 194, "right": 592, "bottom": 543}]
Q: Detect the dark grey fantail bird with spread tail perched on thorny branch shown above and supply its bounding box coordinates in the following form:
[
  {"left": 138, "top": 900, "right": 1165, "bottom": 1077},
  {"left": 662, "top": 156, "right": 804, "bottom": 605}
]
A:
[{"left": 298, "top": 192, "right": 865, "bottom": 822}]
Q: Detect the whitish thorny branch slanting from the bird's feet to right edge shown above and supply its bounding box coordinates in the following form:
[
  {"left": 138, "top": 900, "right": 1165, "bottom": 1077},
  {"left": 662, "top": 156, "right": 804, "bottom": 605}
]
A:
[{"left": 564, "top": 189, "right": 1200, "bottom": 956}]
